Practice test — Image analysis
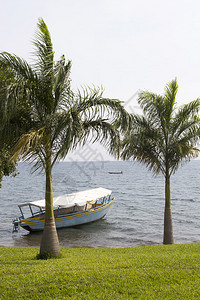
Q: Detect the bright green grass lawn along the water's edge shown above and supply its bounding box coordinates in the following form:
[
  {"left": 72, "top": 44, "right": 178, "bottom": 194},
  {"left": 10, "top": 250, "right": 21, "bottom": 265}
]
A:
[{"left": 0, "top": 244, "right": 200, "bottom": 300}]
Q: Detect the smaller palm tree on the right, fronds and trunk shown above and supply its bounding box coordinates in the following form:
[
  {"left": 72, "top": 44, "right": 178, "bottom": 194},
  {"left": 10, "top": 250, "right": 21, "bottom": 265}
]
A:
[{"left": 121, "top": 79, "right": 200, "bottom": 244}]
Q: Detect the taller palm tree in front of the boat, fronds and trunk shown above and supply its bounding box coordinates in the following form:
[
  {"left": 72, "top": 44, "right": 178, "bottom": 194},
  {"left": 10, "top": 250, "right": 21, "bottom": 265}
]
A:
[{"left": 0, "top": 19, "right": 128, "bottom": 256}]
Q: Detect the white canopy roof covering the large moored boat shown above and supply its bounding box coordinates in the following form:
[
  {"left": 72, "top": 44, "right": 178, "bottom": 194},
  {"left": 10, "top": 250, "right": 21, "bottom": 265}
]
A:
[{"left": 18, "top": 187, "right": 112, "bottom": 209}]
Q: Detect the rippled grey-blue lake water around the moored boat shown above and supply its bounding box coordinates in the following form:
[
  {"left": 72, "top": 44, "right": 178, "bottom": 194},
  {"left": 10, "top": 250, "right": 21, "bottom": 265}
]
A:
[{"left": 0, "top": 160, "right": 200, "bottom": 247}]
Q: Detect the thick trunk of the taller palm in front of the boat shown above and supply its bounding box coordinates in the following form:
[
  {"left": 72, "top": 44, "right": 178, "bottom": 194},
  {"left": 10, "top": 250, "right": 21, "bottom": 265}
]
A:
[{"left": 40, "top": 150, "right": 60, "bottom": 256}]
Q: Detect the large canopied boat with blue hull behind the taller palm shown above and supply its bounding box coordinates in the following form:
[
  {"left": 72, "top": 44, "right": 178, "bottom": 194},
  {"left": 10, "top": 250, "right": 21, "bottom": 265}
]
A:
[{"left": 13, "top": 187, "right": 114, "bottom": 231}]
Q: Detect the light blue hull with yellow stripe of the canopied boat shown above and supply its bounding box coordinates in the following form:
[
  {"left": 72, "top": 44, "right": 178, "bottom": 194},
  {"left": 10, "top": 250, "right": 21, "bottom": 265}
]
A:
[{"left": 20, "top": 198, "right": 114, "bottom": 231}]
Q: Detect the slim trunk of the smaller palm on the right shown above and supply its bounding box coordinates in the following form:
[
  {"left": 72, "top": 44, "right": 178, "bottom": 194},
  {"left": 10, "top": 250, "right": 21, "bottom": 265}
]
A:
[{"left": 163, "top": 172, "right": 174, "bottom": 245}]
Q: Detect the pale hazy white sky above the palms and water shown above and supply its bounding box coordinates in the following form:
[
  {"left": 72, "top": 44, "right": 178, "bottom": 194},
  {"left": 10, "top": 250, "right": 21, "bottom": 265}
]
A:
[{"left": 0, "top": 0, "right": 200, "bottom": 159}]
